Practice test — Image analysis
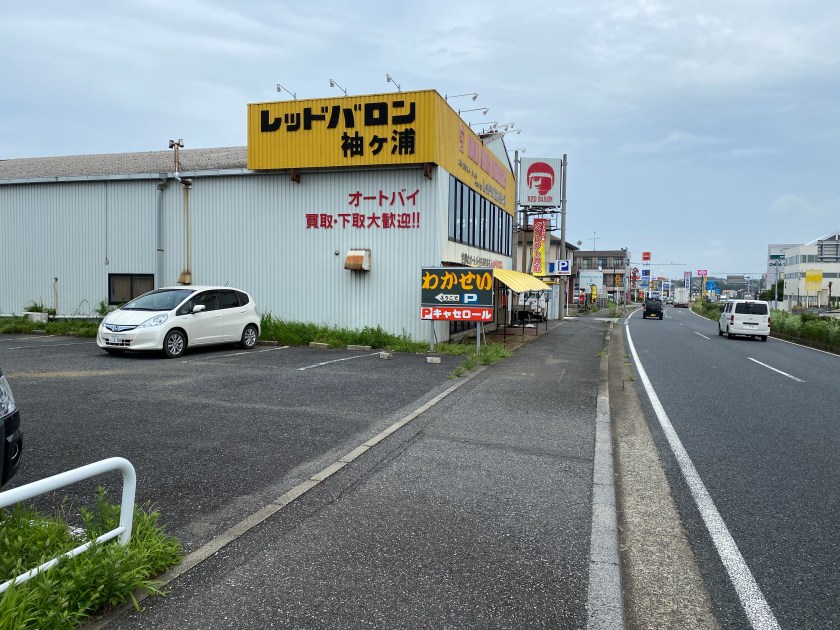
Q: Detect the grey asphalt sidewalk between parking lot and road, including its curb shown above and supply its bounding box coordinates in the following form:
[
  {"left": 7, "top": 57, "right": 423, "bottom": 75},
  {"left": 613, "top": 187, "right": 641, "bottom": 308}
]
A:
[{"left": 100, "top": 316, "right": 623, "bottom": 630}]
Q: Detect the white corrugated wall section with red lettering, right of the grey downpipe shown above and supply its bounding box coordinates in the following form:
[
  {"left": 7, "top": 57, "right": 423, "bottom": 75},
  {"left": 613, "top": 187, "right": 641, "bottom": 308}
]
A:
[{"left": 165, "top": 168, "right": 448, "bottom": 339}]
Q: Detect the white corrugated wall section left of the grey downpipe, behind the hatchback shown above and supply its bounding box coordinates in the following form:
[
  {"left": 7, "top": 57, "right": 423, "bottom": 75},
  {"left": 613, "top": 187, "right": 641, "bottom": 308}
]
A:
[{"left": 0, "top": 181, "right": 154, "bottom": 315}]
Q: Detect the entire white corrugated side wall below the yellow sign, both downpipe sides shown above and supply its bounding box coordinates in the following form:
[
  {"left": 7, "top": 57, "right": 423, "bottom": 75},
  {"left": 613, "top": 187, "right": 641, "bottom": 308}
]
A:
[{"left": 0, "top": 167, "right": 506, "bottom": 340}]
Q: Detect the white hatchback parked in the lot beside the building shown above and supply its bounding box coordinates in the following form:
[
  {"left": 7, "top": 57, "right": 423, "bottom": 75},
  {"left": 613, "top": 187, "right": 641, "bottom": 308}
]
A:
[{"left": 96, "top": 286, "right": 260, "bottom": 358}]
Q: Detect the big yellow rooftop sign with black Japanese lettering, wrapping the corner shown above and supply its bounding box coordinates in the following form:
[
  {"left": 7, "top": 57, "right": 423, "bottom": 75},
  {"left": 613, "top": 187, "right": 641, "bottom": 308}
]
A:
[{"left": 248, "top": 90, "right": 516, "bottom": 214}]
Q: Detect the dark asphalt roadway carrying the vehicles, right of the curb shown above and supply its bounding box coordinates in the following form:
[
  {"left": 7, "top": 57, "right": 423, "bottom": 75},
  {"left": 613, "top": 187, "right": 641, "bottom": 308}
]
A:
[{"left": 628, "top": 308, "right": 840, "bottom": 628}]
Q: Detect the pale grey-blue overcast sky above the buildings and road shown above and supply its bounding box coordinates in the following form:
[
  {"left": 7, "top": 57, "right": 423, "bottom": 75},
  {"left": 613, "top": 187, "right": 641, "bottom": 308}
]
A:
[{"left": 0, "top": 0, "right": 840, "bottom": 277}]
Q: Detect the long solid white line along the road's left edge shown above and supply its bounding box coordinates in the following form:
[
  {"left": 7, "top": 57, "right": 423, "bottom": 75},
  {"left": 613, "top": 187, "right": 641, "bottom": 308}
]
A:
[{"left": 627, "top": 328, "right": 780, "bottom": 630}]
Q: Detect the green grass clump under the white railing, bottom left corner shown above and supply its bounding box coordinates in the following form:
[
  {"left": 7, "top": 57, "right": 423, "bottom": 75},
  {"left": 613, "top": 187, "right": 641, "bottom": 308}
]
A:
[{"left": 0, "top": 488, "right": 182, "bottom": 630}]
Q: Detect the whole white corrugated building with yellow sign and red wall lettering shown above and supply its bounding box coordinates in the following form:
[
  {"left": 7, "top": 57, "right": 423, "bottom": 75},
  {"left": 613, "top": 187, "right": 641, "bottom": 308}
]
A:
[{"left": 0, "top": 91, "right": 540, "bottom": 340}]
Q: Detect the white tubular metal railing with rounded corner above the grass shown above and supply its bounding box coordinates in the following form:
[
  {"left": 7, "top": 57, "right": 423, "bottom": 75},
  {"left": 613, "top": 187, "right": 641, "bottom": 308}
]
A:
[{"left": 0, "top": 457, "right": 137, "bottom": 594}]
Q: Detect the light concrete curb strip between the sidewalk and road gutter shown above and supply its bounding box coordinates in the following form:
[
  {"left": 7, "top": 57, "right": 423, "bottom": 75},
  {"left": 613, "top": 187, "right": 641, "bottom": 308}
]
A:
[{"left": 586, "top": 322, "right": 624, "bottom": 630}]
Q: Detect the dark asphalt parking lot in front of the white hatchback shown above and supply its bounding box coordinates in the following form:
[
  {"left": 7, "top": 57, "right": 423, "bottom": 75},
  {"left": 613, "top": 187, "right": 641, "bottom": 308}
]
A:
[{"left": 0, "top": 335, "right": 462, "bottom": 552}]
